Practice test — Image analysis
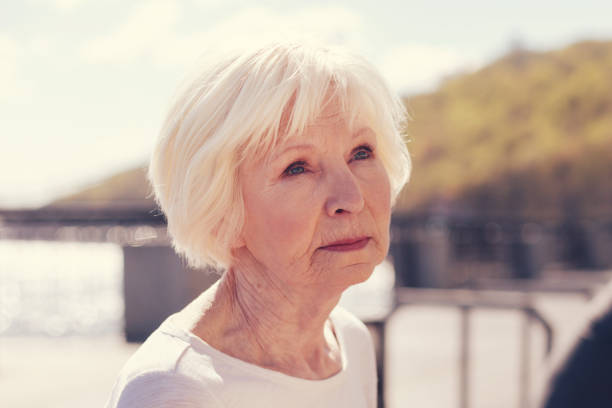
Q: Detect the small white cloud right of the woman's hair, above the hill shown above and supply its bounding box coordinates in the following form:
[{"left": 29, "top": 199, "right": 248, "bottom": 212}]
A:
[{"left": 378, "top": 44, "right": 480, "bottom": 93}]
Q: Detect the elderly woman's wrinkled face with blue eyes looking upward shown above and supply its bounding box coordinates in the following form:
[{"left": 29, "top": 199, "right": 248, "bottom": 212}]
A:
[{"left": 235, "top": 103, "right": 391, "bottom": 290}]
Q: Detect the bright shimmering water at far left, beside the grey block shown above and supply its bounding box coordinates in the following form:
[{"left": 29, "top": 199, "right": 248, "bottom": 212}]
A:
[{"left": 0, "top": 241, "right": 123, "bottom": 336}]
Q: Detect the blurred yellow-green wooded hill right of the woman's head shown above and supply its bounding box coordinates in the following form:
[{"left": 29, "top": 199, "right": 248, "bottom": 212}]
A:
[{"left": 398, "top": 41, "right": 612, "bottom": 217}]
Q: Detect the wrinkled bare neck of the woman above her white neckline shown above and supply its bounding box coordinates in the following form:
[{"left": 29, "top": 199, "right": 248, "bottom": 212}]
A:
[{"left": 189, "top": 258, "right": 341, "bottom": 379}]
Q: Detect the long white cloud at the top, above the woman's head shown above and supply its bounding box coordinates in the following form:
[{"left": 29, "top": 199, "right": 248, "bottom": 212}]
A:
[{"left": 82, "top": 1, "right": 362, "bottom": 66}]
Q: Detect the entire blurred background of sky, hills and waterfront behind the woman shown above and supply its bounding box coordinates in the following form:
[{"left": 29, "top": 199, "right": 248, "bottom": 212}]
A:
[{"left": 0, "top": 0, "right": 612, "bottom": 408}]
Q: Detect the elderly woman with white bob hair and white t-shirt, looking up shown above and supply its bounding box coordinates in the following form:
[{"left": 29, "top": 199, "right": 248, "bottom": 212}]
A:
[{"left": 107, "top": 39, "right": 410, "bottom": 408}]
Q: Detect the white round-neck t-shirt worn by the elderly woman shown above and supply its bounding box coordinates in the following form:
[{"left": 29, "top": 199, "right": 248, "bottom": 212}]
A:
[{"left": 106, "top": 307, "right": 377, "bottom": 408}]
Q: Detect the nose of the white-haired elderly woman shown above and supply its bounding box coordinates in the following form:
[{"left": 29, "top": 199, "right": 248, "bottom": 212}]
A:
[{"left": 325, "top": 168, "right": 364, "bottom": 217}]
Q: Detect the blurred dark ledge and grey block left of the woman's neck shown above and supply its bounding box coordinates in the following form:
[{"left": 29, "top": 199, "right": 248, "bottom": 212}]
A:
[{"left": 0, "top": 203, "right": 218, "bottom": 342}]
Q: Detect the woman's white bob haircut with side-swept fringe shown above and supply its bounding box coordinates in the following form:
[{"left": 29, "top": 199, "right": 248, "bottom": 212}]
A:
[{"left": 149, "top": 42, "right": 410, "bottom": 268}]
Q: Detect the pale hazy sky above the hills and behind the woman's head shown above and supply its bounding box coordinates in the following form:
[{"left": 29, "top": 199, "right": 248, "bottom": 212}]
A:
[{"left": 0, "top": 0, "right": 612, "bottom": 208}]
